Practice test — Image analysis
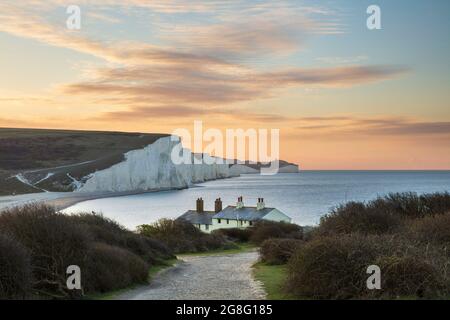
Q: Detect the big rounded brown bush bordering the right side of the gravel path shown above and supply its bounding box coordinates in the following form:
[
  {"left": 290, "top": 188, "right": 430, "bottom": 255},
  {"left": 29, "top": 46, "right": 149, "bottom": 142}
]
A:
[{"left": 287, "top": 235, "right": 376, "bottom": 299}]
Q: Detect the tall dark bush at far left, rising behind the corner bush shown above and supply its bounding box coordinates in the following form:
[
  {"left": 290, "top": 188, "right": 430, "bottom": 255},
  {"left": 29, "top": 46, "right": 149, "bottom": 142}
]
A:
[{"left": 0, "top": 205, "right": 90, "bottom": 298}]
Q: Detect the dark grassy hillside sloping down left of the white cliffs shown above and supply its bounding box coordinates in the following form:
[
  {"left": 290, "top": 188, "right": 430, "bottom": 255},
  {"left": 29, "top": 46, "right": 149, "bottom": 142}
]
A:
[{"left": 0, "top": 128, "right": 167, "bottom": 195}]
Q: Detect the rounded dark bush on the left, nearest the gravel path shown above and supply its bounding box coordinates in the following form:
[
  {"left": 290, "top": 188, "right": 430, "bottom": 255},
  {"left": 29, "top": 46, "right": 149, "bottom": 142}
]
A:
[{"left": 83, "top": 243, "right": 149, "bottom": 292}]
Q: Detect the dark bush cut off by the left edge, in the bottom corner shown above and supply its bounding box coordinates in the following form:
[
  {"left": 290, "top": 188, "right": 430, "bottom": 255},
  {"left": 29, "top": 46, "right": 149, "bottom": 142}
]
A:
[{"left": 0, "top": 234, "right": 32, "bottom": 299}]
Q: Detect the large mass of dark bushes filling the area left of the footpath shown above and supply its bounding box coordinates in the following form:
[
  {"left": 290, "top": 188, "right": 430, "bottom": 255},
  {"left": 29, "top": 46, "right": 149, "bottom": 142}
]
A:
[{"left": 0, "top": 205, "right": 173, "bottom": 298}]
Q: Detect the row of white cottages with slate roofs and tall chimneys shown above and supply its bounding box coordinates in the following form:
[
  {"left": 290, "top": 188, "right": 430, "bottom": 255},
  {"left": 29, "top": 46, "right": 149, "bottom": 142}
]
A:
[{"left": 178, "top": 197, "right": 292, "bottom": 233}]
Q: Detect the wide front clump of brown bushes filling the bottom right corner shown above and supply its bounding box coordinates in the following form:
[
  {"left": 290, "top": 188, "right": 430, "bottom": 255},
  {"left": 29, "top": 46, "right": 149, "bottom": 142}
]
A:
[{"left": 287, "top": 235, "right": 450, "bottom": 299}]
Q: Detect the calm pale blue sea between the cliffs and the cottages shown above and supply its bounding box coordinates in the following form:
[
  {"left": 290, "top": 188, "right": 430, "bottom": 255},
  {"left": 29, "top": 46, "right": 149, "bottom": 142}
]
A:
[{"left": 66, "top": 171, "right": 450, "bottom": 229}]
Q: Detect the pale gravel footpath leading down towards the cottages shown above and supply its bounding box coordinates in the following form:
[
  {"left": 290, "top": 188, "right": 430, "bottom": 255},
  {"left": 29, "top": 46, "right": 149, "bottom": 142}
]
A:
[{"left": 116, "top": 251, "right": 266, "bottom": 300}]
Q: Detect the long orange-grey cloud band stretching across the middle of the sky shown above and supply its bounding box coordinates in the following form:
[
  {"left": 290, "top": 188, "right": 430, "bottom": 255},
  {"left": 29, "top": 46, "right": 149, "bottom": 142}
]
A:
[{"left": 62, "top": 63, "right": 405, "bottom": 105}]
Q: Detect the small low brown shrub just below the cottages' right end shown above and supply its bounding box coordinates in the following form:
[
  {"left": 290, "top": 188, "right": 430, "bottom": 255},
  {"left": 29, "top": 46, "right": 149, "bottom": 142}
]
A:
[{"left": 250, "top": 221, "right": 303, "bottom": 245}]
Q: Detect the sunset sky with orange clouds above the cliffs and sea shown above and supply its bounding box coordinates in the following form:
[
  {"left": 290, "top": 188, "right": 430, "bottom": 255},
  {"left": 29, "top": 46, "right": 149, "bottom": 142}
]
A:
[{"left": 0, "top": 0, "right": 450, "bottom": 170}]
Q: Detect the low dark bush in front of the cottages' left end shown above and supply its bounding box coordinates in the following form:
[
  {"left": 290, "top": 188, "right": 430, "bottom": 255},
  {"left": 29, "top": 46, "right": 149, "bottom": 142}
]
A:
[{"left": 138, "top": 219, "right": 236, "bottom": 253}]
